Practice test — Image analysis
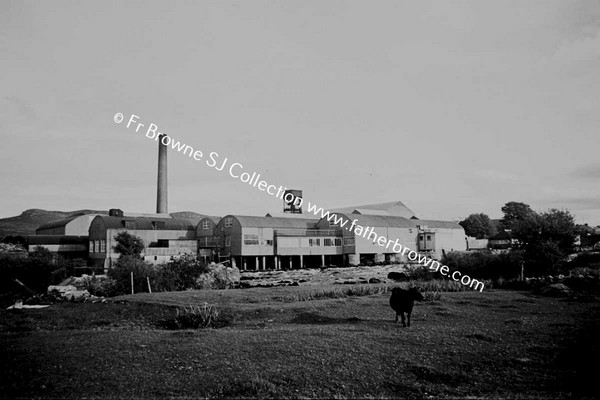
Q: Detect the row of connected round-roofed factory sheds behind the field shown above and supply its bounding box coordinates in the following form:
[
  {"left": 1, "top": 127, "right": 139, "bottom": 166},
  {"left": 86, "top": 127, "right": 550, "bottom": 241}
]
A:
[{"left": 30, "top": 202, "right": 466, "bottom": 271}]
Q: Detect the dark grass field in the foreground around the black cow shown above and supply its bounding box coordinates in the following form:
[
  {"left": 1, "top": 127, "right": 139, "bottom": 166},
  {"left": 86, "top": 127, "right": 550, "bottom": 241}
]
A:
[{"left": 0, "top": 287, "right": 600, "bottom": 399}]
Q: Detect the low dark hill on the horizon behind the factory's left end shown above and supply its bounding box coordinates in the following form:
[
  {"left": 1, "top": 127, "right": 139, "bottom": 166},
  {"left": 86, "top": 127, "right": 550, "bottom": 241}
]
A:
[{"left": 0, "top": 208, "right": 218, "bottom": 239}]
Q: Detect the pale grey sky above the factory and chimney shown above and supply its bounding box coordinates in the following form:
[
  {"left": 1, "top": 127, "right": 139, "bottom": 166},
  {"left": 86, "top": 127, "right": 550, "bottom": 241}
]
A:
[{"left": 0, "top": 0, "right": 600, "bottom": 225}]
